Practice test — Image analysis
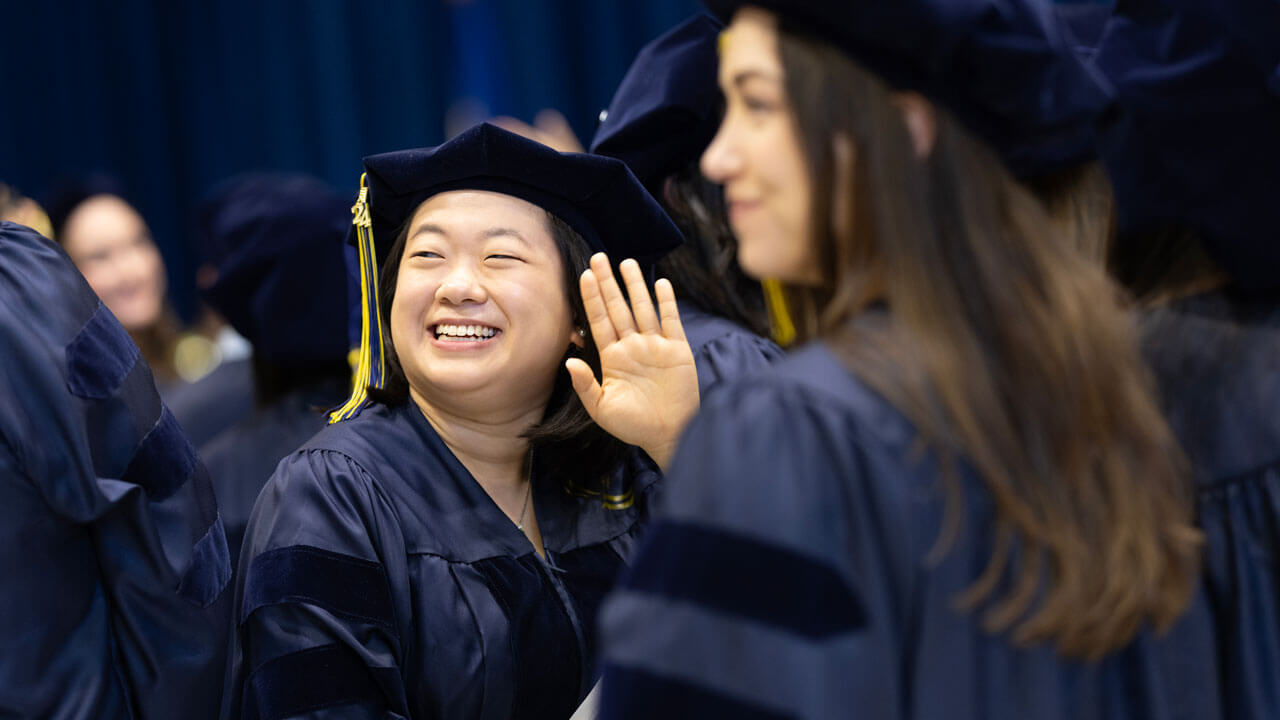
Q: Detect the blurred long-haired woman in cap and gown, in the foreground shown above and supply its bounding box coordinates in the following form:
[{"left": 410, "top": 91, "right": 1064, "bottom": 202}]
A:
[{"left": 602, "top": 0, "right": 1216, "bottom": 719}]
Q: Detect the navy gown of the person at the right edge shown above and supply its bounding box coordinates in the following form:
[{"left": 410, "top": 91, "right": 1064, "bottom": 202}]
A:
[{"left": 1142, "top": 292, "right": 1280, "bottom": 720}]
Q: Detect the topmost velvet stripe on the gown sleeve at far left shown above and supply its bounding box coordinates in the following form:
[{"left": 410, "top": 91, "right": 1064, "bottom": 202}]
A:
[{"left": 67, "top": 302, "right": 140, "bottom": 400}]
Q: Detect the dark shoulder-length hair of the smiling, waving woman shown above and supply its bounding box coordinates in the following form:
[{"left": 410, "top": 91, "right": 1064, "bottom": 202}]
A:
[{"left": 369, "top": 207, "right": 628, "bottom": 491}]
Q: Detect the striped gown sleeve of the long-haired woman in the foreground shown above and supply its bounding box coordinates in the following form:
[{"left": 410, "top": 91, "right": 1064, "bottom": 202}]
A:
[{"left": 600, "top": 384, "right": 909, "bottom": 719}]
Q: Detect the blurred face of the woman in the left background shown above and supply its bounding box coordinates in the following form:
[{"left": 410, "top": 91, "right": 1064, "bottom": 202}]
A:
[{"left": 60, "top": 195, "right": 166, "bottom": 333}]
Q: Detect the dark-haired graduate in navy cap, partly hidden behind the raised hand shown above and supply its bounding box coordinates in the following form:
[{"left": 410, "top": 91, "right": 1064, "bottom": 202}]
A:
[{"left": 591, "top": 15, "right": 782, "bottom": 395}]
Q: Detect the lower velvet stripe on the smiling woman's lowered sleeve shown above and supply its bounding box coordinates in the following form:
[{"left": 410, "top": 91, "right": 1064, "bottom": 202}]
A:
[{"left": 243, "top": 644, "right": 394, "bottom": 720}]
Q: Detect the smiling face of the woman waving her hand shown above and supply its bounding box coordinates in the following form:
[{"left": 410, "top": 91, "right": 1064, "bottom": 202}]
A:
[{"left": 390, "top": 191, "right": 575, "bottom": 407}]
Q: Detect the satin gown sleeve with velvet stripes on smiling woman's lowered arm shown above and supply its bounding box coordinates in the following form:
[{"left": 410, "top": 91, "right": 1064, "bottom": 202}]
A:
[{"left": 229, "top": 450, "right": 410, "bottom": 720}]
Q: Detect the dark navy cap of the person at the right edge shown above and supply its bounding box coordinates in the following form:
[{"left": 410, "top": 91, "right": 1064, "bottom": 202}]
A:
[{"left": 1094, "top": 0, "right": 1280, "bottom": 292}]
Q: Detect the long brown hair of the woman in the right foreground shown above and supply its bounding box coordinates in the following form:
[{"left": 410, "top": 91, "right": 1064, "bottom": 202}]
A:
[{"left": 780, "top": 20, "right": 1201, "bottom": 659}]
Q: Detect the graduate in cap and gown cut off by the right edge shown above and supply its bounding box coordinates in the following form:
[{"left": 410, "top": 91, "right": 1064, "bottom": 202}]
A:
[{"left": 1096, "top": 0, "right": 1280, "bottom": 719}]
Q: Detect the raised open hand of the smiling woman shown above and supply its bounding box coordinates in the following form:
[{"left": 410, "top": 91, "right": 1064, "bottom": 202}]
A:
[{"left": 564, "top": 252, "right": 699, "bottom": 469}]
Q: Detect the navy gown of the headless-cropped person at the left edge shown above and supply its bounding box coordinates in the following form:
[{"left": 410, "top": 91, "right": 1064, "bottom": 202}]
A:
[{"left": 0, "top": 223, "right": 230, "bottom": 720}]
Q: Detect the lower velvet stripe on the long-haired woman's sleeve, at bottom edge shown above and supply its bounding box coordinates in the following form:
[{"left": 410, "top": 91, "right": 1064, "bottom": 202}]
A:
[{"left": 596, "top": 665, "right": 792, "bottom": 720}]
